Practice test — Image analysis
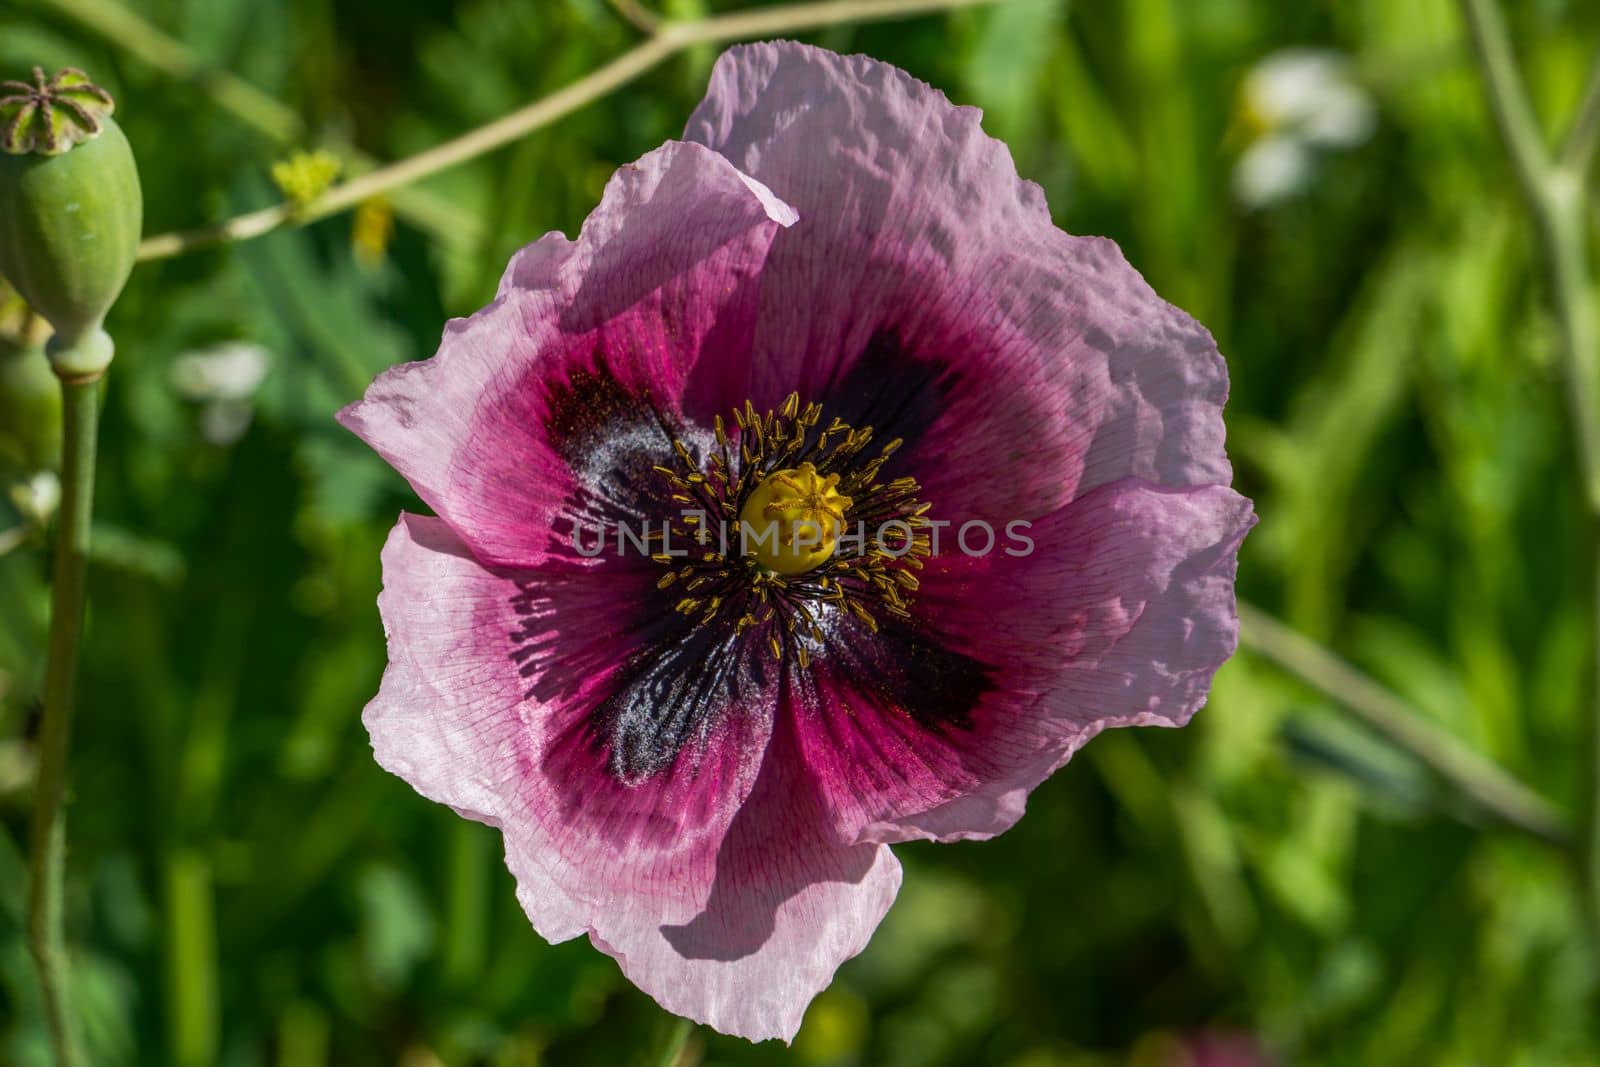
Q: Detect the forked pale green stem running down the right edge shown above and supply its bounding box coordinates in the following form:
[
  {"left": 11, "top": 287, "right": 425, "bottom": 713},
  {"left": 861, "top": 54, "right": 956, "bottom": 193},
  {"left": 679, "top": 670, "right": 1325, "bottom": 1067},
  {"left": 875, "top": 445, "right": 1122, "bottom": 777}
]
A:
[{"left": 1461, "top": 0, "right": 1600, "bottom": 945}]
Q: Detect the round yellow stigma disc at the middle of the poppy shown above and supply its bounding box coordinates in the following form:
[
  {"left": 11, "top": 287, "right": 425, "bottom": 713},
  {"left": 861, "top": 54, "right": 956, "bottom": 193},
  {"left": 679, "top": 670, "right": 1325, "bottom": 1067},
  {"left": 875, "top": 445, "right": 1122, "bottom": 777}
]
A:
[{"left": 739, "top": 462, "right": 851, "bottom": 574}]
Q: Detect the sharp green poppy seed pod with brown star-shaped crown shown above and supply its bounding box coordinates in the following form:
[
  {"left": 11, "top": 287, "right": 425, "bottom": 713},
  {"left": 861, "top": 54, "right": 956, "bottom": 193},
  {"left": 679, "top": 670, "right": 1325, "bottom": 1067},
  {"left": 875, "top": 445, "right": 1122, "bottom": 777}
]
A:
[{"left": 0, "top": 67, "right": 144, "bottom": 378}]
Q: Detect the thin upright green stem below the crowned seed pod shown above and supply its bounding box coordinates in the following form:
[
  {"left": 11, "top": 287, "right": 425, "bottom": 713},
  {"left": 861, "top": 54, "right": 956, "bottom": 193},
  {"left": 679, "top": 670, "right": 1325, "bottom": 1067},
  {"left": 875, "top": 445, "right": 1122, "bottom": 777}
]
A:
[{"left": 27, "top": 378, "right": 99, "bottom": 1067}]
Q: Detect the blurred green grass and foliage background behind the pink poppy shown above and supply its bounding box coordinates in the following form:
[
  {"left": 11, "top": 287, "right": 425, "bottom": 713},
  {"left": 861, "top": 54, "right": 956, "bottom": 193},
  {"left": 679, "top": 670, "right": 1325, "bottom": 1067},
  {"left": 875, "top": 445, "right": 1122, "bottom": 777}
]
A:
[{"left": 0, "top": 0, "right": 1600, "bottom": 1067}]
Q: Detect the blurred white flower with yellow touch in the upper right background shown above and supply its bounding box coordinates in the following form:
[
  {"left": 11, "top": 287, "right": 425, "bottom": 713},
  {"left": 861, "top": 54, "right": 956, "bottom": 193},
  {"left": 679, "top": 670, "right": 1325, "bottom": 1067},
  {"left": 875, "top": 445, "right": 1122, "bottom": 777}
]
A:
[{"left": 1234, "top": 48, "right": 1378, "bottom": 208}]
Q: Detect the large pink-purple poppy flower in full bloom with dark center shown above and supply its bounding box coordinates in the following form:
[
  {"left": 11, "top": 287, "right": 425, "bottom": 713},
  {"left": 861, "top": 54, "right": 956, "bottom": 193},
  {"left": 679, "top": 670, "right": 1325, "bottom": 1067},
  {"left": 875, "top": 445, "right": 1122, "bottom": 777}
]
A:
[{"left": 341, "top": 43, "right": 1254, "bottom": 1040}]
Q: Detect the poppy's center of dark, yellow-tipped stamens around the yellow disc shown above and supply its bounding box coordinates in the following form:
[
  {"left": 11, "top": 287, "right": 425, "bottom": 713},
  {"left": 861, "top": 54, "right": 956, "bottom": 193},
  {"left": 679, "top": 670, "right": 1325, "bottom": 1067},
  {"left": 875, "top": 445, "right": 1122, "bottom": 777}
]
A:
[{"left": 653, "top": 394, "right": 930, "bottom": 667}]
